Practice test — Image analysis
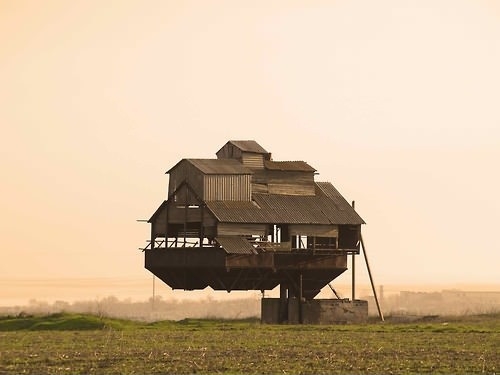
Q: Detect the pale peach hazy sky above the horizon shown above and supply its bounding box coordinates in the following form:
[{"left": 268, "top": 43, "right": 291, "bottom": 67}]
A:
[{"left": 0, "top": 0, "right": 500, "bottom": 290}]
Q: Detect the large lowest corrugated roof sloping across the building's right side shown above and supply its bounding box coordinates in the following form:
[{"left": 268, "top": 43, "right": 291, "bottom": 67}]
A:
[{"left": 206, "top": 182, "right": 365, "bottom": 225}]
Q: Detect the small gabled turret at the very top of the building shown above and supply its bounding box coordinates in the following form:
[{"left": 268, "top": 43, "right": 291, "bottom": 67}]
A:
[{"left": 215, "top": 141, "right": 271, "bottom": 169}]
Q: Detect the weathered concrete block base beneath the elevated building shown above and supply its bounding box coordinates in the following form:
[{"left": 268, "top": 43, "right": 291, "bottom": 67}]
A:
[{"left": 261, "top": 298, "right": 368, "bottom": 324}]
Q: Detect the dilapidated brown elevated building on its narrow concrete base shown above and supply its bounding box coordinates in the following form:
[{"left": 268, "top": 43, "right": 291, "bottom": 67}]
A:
[{"left": 143, "top": 140, "right": 368, "bottom": 323}]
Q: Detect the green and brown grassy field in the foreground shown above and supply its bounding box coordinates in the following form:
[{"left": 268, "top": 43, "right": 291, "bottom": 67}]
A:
[{"left": 0, "top": 314, "right": 500, "bottom": 374}]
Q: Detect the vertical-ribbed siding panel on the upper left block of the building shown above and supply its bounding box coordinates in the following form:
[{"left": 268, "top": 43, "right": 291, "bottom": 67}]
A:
[{"left": 203, "top": 175, "right": 252, "bottom": 201}]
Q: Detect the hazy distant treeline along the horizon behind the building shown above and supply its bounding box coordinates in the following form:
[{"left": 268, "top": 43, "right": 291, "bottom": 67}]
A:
[{"left": 0, "top": 290, "right": 500, "bottom": 322}]
